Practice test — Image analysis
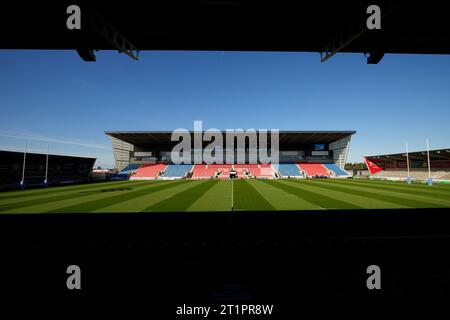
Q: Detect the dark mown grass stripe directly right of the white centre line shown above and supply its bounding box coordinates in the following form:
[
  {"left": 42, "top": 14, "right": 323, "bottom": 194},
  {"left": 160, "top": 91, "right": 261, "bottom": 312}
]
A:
[{"left": 233, "top": 180, "right": 275, "bottom": 211}]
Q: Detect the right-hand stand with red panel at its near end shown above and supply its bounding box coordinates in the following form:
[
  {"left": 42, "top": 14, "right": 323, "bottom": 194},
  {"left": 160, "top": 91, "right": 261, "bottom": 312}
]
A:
[{"left": 364, "top": 148, "right": 450, "bottom": 181}]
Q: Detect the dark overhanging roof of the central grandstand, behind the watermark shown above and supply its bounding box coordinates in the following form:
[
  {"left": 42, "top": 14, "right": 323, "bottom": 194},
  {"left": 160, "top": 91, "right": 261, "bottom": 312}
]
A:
[{"left": 105, "top": 130, "right": 356, "bottom": 145}]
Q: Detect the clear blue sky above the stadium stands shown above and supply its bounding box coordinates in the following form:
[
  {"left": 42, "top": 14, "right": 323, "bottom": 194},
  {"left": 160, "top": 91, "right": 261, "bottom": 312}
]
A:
[{"left": 0, "top": 50, "right": 450, "bottom": 167}]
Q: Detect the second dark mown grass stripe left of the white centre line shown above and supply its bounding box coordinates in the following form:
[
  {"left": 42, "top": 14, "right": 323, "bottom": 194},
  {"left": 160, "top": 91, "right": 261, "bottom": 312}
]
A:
[{"left": 47, "top": 181, "right": 184, "bottom": 213}]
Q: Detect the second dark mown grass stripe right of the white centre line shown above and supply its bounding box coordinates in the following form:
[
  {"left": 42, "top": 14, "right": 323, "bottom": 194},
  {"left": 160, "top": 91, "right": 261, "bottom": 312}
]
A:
[{"left": 265, "top": 180, "right": 361, "bottom": 209}]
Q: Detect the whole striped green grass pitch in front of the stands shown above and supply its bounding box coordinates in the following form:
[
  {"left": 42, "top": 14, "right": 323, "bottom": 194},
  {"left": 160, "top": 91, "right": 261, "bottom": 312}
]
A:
[{"left": 0, "top": 179, "right": 450, "bottom": 213}]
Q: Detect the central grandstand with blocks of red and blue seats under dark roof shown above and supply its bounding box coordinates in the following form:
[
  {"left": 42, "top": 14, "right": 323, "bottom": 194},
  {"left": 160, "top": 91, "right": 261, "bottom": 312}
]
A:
[{"left": 105, "top": 131, "right": 356, "bottom": 179}]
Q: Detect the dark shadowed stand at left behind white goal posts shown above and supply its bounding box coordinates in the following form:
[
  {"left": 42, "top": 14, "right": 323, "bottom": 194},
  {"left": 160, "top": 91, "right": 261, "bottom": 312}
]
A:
[{"left": 0, "top": 151, "right": 96, "bottom": 189}]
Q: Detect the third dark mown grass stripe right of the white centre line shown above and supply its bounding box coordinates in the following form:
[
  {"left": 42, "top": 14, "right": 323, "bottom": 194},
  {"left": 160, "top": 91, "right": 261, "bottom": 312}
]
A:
[{"left": 293, "top": 180, "right": 443, "bottom": 208}]
